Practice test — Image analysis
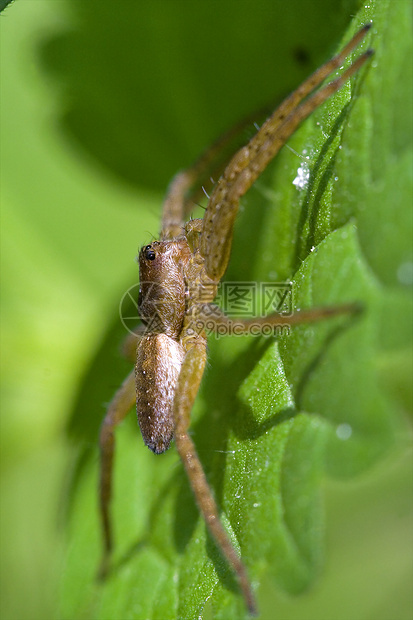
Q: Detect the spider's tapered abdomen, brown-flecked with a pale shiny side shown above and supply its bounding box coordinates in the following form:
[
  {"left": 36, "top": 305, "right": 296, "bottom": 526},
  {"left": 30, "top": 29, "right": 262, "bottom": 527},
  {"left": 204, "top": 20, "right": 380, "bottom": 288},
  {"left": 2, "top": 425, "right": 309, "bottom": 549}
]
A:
[{"left": 135, "top": 334, "right": 185, "bottom": 454}]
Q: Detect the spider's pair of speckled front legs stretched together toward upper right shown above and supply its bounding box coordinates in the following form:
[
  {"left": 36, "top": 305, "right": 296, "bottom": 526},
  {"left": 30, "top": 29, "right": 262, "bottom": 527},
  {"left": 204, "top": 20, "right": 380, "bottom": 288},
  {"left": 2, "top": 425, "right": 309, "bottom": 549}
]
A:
[{"left": 200, "top": 25, "right": 372, "bottom": 281}]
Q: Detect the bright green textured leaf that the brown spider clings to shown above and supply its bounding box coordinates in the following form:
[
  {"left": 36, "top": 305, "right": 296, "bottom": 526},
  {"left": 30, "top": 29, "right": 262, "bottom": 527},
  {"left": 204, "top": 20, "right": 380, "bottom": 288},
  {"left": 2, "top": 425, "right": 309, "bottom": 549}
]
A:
[{"left": 58, "top": 3, "right": 411, "bottom": 618}]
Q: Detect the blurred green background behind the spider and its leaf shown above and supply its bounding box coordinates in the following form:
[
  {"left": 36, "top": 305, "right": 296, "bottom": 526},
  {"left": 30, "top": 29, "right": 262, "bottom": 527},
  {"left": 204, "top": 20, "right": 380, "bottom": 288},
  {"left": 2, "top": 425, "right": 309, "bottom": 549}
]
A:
[{"left": 0, "top": 0, "right": 413, "bottom": 620}]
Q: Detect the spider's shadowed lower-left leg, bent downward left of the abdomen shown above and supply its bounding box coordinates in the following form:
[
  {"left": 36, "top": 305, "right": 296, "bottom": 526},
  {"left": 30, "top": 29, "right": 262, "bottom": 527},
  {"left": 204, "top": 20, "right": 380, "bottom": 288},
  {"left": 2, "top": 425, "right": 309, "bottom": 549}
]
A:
[{"left": 99, "top": 370, "right": 136, "bottom": 577}]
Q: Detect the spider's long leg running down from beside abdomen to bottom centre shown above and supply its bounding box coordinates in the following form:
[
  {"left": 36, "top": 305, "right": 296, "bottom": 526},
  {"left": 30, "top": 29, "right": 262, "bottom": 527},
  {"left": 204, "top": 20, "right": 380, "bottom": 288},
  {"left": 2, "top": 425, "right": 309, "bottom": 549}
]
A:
[{"left": 174, "top": 344, "right": 256, "bottom": 614}]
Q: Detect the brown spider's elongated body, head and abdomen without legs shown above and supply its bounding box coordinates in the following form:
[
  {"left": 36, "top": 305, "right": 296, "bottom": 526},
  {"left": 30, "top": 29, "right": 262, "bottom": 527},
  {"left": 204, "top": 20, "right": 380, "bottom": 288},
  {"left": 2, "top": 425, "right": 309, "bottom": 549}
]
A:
[{"left": 135, "top": 236, "right": 197, "bottom": 454}]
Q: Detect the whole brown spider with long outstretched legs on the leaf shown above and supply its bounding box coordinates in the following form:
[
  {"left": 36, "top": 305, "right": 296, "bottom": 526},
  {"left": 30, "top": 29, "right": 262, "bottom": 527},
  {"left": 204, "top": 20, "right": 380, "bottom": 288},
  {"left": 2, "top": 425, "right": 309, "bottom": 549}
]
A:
[{"left": 100, "top": 24, "right": 372, "bottom": 614}]
